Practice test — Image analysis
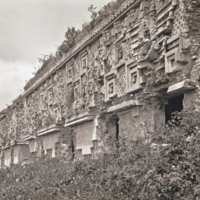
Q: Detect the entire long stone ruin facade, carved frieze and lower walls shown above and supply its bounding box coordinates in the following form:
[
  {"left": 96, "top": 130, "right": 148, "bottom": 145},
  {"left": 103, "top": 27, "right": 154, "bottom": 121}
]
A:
[{"left": 0, "top": 0, "right": 200, "bottom": 166}]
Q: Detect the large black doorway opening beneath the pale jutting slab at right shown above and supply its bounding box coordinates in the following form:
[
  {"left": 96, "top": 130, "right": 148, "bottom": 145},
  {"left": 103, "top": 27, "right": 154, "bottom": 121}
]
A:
[{"left": 165, "top": 95, "right": 184, "bottom": 124}]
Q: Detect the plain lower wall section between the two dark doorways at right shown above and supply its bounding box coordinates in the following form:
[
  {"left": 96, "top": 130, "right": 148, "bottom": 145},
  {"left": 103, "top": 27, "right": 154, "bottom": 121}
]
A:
[{"left": 105, "top": 101, "right": 165, "bottom": 140}]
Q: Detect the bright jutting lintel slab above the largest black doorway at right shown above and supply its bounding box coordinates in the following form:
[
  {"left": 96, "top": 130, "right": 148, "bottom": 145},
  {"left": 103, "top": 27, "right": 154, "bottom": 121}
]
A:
[{"left": 167, "top": 79, "right": 195, "bottom": 95}]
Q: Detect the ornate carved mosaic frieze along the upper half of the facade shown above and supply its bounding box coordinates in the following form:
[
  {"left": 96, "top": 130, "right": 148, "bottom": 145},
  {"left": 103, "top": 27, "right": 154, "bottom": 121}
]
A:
[{"left": 0, "top": 0, "right": 200, "bottom": 159}]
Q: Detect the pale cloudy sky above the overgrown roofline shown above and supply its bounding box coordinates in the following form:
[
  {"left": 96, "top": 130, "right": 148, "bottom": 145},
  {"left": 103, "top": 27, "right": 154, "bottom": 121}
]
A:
[{"left": 0, "top": 0, "right": 111, "bottom": 111}]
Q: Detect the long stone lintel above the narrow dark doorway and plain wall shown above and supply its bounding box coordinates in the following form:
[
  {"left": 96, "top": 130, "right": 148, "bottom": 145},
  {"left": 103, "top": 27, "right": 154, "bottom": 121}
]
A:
[{"left": 107, "top": 100, "right": 142, "bottom": 113}]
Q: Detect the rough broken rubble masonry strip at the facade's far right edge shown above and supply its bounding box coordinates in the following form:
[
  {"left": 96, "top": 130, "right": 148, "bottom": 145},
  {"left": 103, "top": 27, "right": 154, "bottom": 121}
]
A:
[{"left": 184, "top": 0, "right": 200, "bottom": 111}]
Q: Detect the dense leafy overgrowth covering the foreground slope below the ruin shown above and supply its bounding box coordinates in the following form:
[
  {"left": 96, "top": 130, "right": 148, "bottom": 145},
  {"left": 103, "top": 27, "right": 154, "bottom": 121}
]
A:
[{"left": 0, "top": 111, "right": 200, "bottom": 200}]
